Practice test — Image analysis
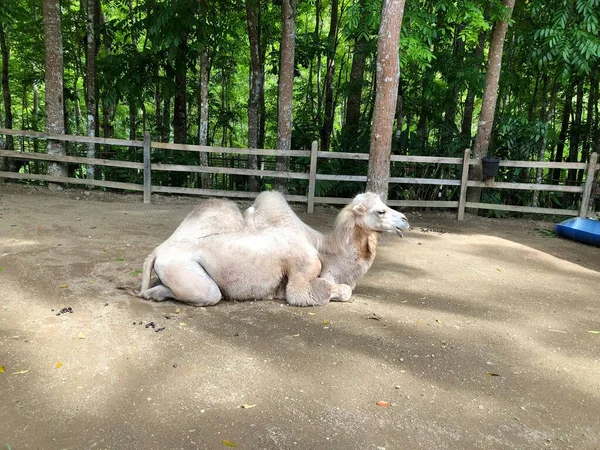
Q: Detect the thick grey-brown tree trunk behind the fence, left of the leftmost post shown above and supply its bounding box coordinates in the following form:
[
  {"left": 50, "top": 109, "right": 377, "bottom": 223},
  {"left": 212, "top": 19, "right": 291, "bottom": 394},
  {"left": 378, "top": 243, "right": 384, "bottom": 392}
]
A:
[{"left": 42, "top": 0, "right": 67, "bottom": 190}]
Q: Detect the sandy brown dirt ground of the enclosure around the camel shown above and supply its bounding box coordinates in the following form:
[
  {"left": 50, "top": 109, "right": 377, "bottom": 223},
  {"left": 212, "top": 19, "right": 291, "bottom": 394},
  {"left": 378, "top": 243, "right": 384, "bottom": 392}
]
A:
[{"left": 0, "top": 185, "right": 600, "bottom": 450}]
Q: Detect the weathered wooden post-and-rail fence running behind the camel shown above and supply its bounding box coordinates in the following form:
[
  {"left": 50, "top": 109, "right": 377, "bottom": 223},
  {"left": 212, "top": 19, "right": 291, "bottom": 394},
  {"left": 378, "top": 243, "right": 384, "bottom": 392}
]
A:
[{"left": 0, "top": 128, "right": 600, "bottom": 220}]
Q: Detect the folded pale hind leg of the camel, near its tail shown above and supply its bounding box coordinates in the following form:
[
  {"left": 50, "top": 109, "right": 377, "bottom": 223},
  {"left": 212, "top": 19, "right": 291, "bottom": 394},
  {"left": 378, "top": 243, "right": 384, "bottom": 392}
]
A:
[{"left": 148, "top": 260, "right": 222, "bottom": 306}]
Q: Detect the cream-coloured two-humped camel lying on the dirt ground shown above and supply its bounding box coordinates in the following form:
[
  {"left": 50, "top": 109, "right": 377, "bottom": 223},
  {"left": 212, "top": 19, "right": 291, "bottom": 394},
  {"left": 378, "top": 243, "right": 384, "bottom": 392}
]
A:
[{"left": 134, "top": 192, "right": 410, "bottom": 306}]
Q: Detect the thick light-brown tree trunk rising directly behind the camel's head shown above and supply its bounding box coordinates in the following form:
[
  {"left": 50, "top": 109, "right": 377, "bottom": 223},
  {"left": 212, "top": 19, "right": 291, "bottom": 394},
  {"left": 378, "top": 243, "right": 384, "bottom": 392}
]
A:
[{"left": 367, "top": 0, "right": 404, "bottom": 201}]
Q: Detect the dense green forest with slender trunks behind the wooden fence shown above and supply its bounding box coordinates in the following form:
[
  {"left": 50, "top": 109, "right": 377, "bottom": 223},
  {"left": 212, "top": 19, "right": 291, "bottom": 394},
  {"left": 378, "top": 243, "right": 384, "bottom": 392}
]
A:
[{"left": 0, "top": 0, "right": 600, "bottom": 208}]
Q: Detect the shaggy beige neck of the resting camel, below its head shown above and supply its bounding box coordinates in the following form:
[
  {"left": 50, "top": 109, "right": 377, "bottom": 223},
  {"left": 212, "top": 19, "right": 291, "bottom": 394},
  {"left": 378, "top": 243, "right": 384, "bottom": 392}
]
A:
[{"left": 320, "top": 220, "right": 377, "bottom": 286}]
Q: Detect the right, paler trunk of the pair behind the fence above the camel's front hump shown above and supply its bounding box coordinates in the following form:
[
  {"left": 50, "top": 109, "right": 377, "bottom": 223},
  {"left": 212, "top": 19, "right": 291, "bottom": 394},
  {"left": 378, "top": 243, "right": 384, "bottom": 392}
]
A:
[{"left": 275, "top": 0, "right": 296, "bottom": 193}]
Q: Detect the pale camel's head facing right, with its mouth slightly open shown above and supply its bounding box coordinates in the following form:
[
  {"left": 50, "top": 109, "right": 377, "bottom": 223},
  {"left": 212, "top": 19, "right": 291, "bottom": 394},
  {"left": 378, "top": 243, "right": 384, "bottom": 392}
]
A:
[{"left": 349, "top": 192, "right": 410, "bottom": 237}]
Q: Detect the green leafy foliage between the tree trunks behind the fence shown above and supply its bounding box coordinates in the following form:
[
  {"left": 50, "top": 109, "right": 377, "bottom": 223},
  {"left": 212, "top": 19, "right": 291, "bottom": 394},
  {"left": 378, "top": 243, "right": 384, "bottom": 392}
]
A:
[{"left": 0, "top": 0, "right": 600, "bottom": 211}]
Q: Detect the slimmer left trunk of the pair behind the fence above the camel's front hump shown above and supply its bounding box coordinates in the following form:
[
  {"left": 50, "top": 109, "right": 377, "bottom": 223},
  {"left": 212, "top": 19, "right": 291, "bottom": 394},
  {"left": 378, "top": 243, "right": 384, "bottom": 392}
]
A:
[{"left": 246, "top": 0, "right": 265, "bottom": 192}]
